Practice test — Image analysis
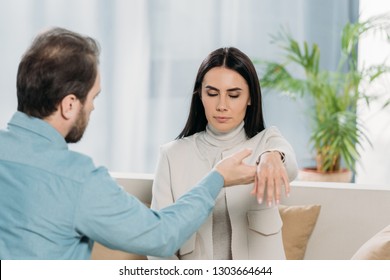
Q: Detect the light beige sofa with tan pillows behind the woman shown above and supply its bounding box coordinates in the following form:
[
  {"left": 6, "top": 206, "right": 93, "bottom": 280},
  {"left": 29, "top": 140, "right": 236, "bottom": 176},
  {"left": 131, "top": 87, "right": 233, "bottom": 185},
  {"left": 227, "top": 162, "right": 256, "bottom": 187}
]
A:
[{"left": 92, "top": 173, "right": 390, "bottom": 260}]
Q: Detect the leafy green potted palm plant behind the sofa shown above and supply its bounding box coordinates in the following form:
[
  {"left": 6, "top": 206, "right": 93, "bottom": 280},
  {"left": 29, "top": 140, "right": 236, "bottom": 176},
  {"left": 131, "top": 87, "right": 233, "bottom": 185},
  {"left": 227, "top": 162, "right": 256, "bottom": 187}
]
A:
[{"left": 255, "top": 15, "right": 390, "bottom": 181}]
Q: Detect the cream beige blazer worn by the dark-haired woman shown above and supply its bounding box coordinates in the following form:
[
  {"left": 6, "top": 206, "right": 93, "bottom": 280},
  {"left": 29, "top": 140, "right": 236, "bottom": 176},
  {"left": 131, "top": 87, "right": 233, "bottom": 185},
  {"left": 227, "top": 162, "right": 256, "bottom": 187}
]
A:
[{"left": 151, "top": 127, "right": 297, "bottom": 259}]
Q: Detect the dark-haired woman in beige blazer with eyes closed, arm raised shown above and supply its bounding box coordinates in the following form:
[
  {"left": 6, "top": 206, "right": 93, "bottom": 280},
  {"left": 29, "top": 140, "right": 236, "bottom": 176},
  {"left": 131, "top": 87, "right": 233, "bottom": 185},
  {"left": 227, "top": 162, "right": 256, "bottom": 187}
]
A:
[{"left": 151, "top": 48, "right": 297, "bottom": 259}]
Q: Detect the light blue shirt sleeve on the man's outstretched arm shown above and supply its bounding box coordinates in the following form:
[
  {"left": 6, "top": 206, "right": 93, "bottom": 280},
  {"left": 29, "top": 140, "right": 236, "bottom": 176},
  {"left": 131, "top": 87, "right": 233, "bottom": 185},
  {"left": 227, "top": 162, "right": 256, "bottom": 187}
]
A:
[{"left": 74, "top": 165, "right": 224, "bottom": 257}]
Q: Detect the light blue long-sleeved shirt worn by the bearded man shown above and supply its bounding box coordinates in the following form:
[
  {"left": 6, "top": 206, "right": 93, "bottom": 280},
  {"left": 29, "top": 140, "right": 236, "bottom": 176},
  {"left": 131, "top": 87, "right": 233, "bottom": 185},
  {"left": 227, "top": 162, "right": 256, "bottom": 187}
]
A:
[{"left": 0, "top": 112, "right": 223, "bottom": 259}]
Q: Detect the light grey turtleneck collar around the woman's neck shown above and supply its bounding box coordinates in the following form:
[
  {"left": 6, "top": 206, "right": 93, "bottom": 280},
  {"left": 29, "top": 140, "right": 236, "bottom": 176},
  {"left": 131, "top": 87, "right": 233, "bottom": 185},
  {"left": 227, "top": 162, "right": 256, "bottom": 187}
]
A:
[{"left": 204, "top": 122, "right": 247, "bottom": 149}]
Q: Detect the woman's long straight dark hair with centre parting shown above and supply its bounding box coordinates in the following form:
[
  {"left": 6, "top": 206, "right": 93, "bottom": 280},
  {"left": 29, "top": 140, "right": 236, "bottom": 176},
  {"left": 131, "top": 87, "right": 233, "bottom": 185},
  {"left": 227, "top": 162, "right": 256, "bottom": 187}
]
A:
[{"left": 176, "top": 47, "right": 265, "bottom": 139}]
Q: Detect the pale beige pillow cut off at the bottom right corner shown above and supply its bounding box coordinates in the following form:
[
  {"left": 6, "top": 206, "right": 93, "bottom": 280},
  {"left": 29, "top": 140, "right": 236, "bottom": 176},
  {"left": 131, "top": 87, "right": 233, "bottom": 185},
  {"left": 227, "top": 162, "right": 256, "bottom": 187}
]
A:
[{"left": 352, "top": 225, "right": 390, "bottom": 260}]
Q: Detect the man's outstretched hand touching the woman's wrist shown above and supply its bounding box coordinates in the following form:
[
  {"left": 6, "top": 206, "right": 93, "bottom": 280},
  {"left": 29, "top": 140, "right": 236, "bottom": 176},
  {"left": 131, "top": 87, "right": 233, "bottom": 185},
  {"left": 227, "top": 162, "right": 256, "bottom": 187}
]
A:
[{"left": 215, "top": 149, "right": 256, "bottom": 187}]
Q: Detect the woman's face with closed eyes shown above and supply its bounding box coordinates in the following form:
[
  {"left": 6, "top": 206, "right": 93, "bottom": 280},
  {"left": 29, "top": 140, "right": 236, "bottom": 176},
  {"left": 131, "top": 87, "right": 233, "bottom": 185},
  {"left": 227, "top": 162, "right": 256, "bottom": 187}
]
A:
[{"left": 201, "top": 67, "right": 250, "bottom": 132}]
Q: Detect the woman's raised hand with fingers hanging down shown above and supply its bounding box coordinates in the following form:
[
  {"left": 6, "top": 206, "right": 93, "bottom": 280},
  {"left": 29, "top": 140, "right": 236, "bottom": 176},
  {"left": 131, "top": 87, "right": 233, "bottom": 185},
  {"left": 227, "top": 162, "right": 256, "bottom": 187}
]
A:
[{"left": 251, "top": 151, "right": 290, "bottom": 206}]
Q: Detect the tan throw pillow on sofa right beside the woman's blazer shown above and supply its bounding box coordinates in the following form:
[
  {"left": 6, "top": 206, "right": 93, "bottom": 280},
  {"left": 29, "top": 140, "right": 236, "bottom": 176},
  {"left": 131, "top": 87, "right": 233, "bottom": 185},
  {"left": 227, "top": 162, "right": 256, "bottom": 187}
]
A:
[{"left": 279, "top": 205, "right": 321, "bottom": 260}]
